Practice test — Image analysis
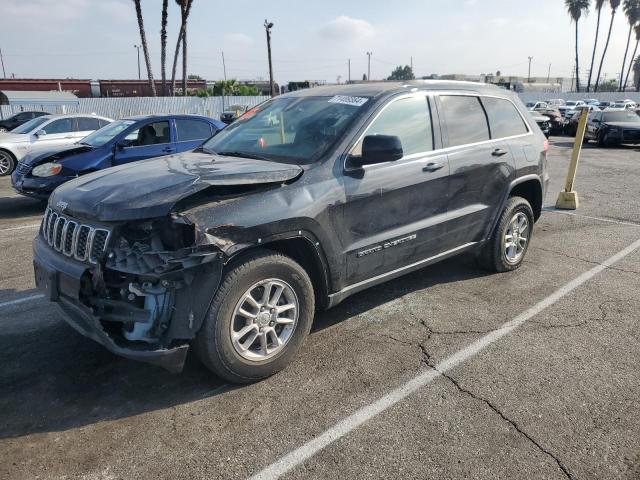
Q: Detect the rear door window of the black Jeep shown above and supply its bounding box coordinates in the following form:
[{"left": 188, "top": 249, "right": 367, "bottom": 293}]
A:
[{"left": 440, "top": 95, "right": 489, "bottom": 147}]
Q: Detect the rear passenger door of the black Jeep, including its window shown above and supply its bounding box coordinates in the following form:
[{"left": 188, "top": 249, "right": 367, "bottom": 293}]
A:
[{"left": 439, "top": 94, "right": 522, "bottom": 248}]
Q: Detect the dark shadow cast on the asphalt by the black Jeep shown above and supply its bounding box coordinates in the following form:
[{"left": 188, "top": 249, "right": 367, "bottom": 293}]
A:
[{"left": 0, "top": 257, "right": 485, "bottom": 438}]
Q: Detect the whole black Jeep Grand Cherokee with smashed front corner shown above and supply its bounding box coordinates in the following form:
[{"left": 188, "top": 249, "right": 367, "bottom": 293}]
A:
[{"left": 33, "top": 81, "right": 547, "bottom": 382}]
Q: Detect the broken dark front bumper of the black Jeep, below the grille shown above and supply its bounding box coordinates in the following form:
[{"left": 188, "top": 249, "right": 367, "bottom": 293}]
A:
[{"left": 33, "top": 235, "right": 199, "bottom": 372}]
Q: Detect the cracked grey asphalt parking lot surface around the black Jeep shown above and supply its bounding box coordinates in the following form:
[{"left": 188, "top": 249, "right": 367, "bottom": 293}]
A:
[{"left": 0, "top": 137, "right": 640, "bottom": 479}]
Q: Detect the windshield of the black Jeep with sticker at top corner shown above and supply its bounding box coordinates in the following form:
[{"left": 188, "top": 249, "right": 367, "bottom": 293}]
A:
[{"left": 202, "top": 95, "right": 369, "bottom": 163}]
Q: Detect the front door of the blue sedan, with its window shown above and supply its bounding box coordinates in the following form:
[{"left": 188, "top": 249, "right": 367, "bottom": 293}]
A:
[{"left": 114, "top": 120, "right": 176, "bottom": 165}]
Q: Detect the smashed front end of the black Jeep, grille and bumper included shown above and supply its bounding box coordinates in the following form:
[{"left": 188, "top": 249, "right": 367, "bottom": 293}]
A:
[{"left": 34, "top": 208, "right": 223, "bottom": 371}]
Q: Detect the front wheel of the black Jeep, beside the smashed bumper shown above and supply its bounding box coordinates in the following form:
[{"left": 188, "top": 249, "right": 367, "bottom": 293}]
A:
[{"left": 194, "top": 251, "right": 315, "bottom": 383}]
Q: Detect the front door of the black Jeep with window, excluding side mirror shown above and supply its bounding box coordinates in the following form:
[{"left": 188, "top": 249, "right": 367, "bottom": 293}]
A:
[{"left": 341, "top": 93, "right": 449, "bottom": 285}]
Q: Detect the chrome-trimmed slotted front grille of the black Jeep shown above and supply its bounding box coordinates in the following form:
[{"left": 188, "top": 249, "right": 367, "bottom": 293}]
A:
[{"left": 42, "top": 208, "right": 111, "bottom": 263}]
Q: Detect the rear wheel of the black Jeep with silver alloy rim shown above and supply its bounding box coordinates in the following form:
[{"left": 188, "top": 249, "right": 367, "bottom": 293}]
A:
[{"left": 478, "top": 197, "right": 534, "bottom": 273}]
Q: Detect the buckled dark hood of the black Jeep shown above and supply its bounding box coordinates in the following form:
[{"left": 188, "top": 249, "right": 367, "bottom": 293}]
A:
[{"left": 49, "top": 152, "right": 302, "bottom": 222}]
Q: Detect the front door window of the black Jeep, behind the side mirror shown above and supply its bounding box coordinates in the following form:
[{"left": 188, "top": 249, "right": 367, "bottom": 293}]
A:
[{"left": 351, "top": 96, "right": 433, "bottom": 156}]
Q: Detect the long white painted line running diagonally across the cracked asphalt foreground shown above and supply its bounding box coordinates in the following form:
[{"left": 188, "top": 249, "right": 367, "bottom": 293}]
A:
[{"left": 251, "top": 240, "right": 640, "bottom": 480}]
